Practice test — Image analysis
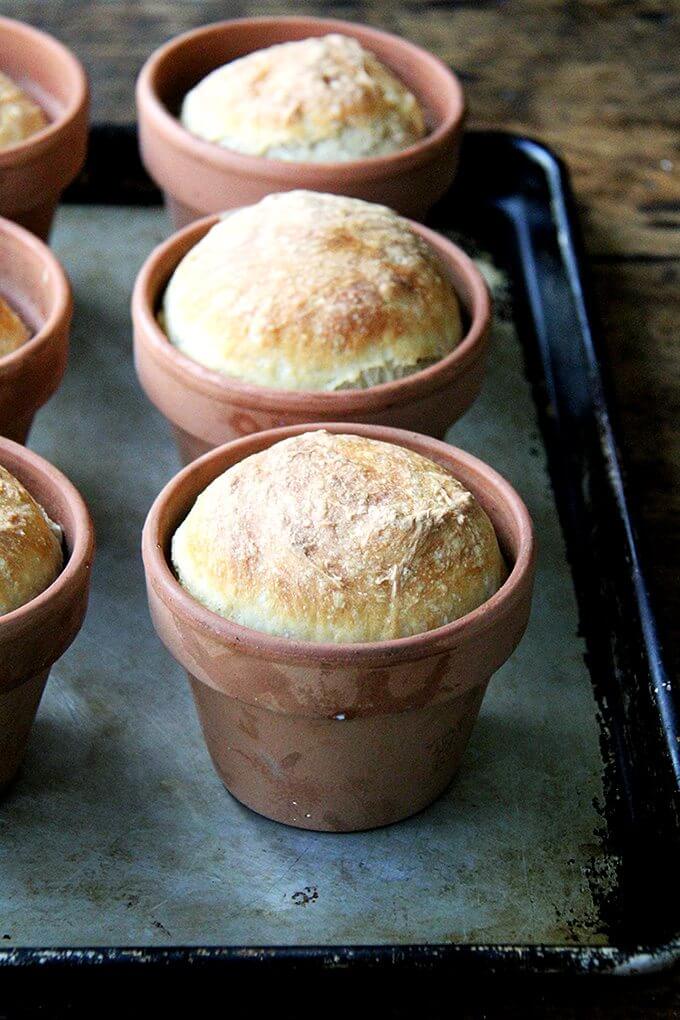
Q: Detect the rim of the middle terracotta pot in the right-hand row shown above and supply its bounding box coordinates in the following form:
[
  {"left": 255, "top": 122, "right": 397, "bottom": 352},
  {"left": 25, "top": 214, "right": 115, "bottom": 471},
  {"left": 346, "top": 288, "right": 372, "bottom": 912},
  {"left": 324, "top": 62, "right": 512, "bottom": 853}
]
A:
[{"left": 132, "top": 210, "right": 491, "bottom": 420}]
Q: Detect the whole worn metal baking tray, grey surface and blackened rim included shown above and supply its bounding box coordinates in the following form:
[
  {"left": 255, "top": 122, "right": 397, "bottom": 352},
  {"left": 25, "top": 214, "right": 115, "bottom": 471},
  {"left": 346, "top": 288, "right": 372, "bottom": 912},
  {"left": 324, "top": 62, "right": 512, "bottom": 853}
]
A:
[{"left": 0, "top": 129, "right": 680, "bottom": 995}]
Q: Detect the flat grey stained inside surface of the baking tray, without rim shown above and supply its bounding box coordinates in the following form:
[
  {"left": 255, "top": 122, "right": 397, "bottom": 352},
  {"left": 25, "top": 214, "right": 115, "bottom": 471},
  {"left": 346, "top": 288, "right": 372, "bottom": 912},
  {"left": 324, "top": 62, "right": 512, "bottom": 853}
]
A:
[{"left": 0, "top": 206, "right": 618, "bottom": 950}]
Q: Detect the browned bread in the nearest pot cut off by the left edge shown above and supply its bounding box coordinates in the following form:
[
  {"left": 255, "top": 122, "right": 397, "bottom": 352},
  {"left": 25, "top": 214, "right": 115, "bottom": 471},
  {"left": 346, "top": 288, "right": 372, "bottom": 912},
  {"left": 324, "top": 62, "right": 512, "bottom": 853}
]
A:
[{"left": 0, "top": 466, "right": 63, "bottom": 615}]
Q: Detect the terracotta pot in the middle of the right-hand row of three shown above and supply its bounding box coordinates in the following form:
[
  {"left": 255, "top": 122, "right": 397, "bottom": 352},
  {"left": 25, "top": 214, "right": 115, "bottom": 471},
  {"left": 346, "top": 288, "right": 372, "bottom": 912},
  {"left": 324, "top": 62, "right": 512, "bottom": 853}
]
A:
[{"left": 133, "top": 216, "right": 491, "bottom": 463}]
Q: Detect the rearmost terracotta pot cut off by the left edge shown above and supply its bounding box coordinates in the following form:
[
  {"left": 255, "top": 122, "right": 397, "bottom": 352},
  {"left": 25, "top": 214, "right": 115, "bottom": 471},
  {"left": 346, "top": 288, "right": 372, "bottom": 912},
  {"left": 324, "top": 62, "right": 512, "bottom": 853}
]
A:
[{"left": 0, "top": 17, "right": 90, "bottom": 239}]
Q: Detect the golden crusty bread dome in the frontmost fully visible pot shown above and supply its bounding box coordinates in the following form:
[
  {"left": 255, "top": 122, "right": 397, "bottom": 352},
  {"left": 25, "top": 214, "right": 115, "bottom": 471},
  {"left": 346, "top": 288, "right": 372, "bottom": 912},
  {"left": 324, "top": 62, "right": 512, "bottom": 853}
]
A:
[{"left": 171, "top": 430, "right": 505, "bottom": 643}]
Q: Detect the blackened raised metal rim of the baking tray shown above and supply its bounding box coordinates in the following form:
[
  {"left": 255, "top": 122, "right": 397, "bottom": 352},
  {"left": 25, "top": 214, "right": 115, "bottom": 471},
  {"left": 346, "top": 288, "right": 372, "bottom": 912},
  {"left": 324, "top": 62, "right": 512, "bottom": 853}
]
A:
[{"left": 0, "top": 125, "right": 680, "bottom": 980}]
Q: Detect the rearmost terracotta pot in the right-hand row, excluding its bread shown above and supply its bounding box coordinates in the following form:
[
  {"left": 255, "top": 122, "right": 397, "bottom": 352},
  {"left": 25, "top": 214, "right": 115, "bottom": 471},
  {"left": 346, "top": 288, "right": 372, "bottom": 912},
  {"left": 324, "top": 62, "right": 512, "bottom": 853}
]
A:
[{"left": 137, "top": 17, "right": 465, "bottom": 226}]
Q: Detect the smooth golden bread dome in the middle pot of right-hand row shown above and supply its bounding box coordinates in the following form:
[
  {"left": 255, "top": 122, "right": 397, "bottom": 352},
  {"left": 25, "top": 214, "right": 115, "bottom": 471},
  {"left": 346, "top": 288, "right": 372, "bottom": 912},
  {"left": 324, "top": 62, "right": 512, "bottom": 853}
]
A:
[{"left": 163, "top": 191, "right": 463, "bottom": 391}]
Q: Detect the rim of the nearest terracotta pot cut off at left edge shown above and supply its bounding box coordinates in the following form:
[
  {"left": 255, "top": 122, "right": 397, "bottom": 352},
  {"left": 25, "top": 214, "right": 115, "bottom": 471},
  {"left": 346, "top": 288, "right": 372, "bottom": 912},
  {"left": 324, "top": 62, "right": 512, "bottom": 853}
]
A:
[{"left": 0, "top": 437, "right": 95, "bottom": 632}]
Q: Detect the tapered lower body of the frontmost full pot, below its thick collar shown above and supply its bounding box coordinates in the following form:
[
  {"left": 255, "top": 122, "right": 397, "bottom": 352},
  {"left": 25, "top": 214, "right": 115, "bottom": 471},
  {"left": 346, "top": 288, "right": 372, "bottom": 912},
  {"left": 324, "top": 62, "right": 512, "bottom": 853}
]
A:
[{"left": 189, "top": 673, "right": 486, "bottom": 832}]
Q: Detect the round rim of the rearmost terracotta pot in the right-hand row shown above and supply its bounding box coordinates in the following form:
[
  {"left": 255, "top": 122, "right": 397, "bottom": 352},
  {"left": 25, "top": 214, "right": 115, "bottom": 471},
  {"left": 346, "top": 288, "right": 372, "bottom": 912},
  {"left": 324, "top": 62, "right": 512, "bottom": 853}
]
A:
[{"left": 137, "top": 14, "right": 466, "bottom": 179}]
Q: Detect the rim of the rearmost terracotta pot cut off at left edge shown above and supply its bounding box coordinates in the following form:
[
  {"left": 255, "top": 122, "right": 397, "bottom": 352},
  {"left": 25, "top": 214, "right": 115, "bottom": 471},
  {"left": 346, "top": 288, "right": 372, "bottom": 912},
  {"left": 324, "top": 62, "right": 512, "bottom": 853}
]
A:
[{"left": 0, "top": 16, "right": 90, "bottom": 168}]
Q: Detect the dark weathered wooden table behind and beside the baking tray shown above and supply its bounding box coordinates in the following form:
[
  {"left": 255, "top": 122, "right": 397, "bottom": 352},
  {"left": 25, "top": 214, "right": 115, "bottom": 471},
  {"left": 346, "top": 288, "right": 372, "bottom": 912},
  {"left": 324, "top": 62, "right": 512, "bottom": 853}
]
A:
[{"left": 0, "top": 0, "right": 680, "bottom": 1016}]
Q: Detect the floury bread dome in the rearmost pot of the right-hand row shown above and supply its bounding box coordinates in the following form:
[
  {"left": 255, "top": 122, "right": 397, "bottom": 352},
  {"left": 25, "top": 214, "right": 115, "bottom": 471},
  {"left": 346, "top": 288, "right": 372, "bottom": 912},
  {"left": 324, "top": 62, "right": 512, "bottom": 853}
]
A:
[{"left": 180, "top": 34, "right": 425, "bottom": 163}]
